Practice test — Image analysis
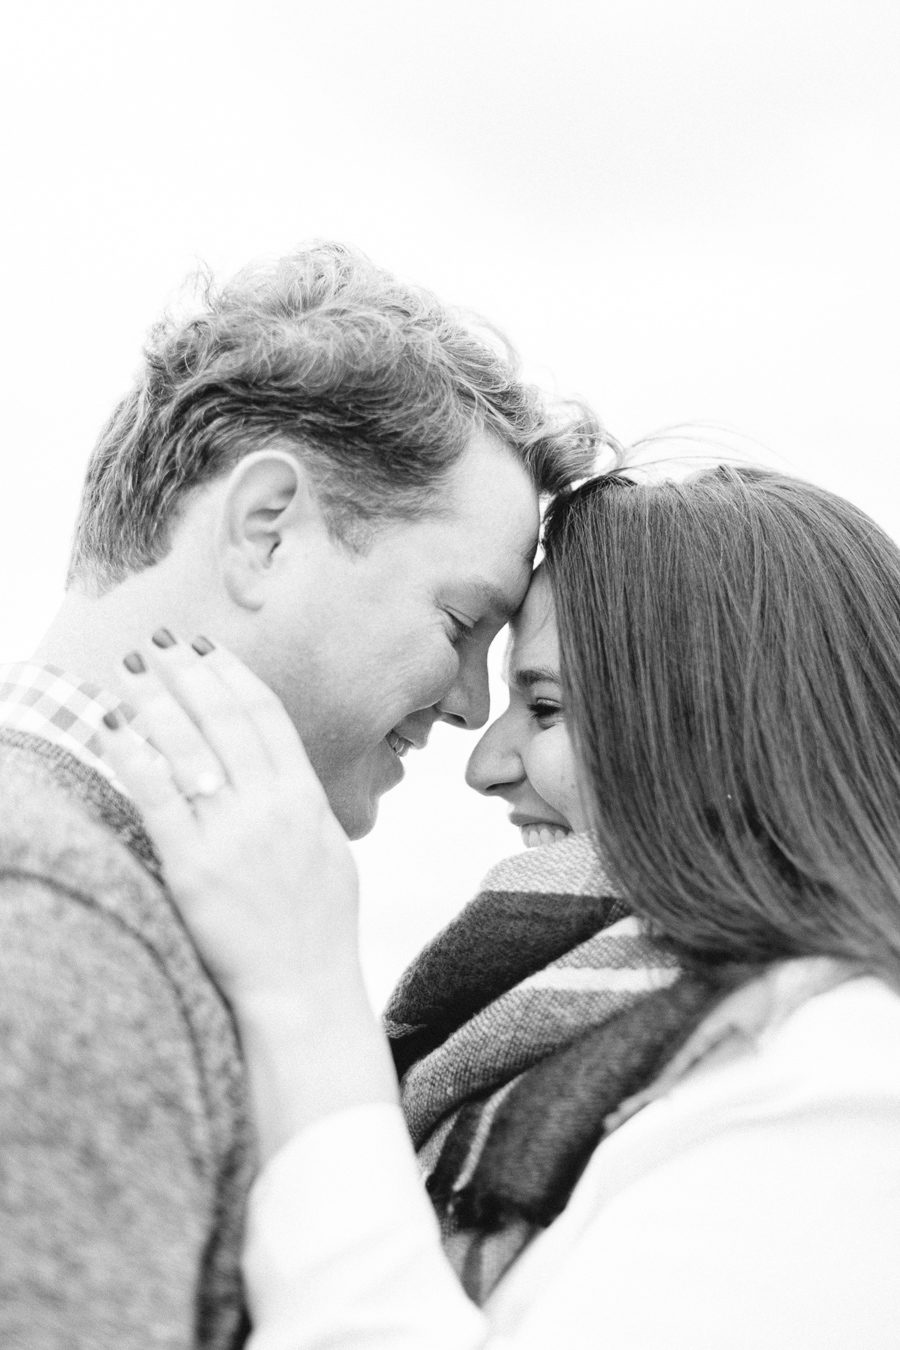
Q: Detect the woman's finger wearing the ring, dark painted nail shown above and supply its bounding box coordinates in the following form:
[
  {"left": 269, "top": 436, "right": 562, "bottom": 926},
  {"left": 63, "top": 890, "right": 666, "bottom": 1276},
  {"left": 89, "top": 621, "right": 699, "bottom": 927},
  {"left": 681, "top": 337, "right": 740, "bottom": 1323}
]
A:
[{"left": 117, "top": 648, "right": 227, "bottom": 798}]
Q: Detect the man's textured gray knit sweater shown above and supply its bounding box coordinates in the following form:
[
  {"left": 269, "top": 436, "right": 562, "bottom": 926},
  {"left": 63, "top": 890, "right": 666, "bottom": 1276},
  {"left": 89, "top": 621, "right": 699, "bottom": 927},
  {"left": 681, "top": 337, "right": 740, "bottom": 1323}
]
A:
[{"left": 0, "top": 730, "right": 254, "bottom": 1350}]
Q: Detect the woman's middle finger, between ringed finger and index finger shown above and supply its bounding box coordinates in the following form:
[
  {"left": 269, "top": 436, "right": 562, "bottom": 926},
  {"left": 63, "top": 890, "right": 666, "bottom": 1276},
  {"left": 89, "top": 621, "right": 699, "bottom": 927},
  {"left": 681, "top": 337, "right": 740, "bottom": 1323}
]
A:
[{"left": 138, "top": 628, "right": 274, "bottom": 787}]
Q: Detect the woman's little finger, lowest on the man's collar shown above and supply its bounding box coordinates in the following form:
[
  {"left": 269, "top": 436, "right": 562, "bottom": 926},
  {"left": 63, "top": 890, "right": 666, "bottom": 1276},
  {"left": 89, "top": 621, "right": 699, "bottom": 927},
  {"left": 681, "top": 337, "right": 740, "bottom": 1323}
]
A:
[{"left": 97, "top": 713, "right": 200, "bottom": 859}]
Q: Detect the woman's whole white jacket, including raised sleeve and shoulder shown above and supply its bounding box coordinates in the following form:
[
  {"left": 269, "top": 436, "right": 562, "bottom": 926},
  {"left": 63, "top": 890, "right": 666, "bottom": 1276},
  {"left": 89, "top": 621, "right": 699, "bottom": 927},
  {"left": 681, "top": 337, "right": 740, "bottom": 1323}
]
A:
[{"left": 238, "top": 976, "right": 900, "bottom": 1350}]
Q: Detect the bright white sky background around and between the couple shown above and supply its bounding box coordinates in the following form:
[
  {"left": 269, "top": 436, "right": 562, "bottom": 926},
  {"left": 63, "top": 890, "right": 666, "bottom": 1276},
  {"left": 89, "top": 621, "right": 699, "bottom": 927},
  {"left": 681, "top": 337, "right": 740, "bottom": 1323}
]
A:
[{"left": 0, "top": 0, "right": 900, "bottom": 996}]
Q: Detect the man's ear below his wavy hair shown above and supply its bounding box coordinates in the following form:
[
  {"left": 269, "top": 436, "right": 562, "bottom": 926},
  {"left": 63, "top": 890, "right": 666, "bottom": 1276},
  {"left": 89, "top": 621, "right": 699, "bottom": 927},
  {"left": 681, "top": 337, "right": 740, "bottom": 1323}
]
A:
[{"left": 217, "top": 450, "right": 321, "bottom": 609}]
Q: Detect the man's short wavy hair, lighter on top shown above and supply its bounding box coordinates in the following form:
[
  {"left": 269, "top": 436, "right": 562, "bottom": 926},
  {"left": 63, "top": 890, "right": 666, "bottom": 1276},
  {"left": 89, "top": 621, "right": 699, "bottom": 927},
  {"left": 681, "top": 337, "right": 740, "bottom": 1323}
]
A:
[{"left": 69, "top": 243, "right": 604, "bottom": 591}]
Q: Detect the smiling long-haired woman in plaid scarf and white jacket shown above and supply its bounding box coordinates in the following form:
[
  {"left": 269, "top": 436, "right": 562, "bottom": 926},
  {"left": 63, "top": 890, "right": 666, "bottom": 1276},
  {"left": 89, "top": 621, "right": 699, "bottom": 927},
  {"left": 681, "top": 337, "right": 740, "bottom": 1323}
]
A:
[{"left": 97, "top": 470, "right": 900, "bottom": 1350}]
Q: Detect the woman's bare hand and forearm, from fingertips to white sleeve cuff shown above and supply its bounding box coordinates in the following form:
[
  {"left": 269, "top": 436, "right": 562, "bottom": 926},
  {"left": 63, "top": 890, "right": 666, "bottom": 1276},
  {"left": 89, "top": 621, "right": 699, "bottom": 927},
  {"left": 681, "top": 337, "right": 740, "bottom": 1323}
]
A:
[{"left": 101, "top": 629, "right": 395, "bottom": 1154}]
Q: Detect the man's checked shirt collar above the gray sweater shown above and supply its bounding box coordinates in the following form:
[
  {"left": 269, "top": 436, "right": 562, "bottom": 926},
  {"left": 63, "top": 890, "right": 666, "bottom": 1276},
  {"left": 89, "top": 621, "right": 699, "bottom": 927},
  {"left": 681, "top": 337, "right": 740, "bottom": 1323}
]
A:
[{"left": 0, "top": 662, "right": 128, "bottom": 795}]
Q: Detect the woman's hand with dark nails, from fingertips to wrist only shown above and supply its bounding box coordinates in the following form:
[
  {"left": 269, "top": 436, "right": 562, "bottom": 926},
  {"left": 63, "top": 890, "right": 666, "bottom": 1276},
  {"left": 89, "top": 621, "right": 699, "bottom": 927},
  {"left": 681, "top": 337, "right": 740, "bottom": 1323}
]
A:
[{"left": 104, "top": 635, "right": 358, "bottom": 999}]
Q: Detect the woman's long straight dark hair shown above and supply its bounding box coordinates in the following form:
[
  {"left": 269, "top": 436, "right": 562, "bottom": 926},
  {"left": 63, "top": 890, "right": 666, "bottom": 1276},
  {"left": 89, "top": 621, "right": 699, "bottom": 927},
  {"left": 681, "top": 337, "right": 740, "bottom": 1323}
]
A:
[{"left": 545, "top": 468, "right": 900, "bottom": 979}]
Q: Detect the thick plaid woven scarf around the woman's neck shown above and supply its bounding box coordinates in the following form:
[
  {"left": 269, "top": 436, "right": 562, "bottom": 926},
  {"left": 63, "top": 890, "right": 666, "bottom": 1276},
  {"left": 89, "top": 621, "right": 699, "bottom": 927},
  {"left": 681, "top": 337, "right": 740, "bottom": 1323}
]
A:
[{"left": 386, "top": 834, "right": 727, "bottom": 1304}]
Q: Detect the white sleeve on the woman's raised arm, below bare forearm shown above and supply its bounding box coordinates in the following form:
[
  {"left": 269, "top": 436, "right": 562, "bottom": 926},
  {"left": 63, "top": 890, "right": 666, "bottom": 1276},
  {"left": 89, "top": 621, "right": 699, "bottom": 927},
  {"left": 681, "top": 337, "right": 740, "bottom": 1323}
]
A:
[{"left": 244, "top": 1104, "right": 487, "bottom": 1350}]
